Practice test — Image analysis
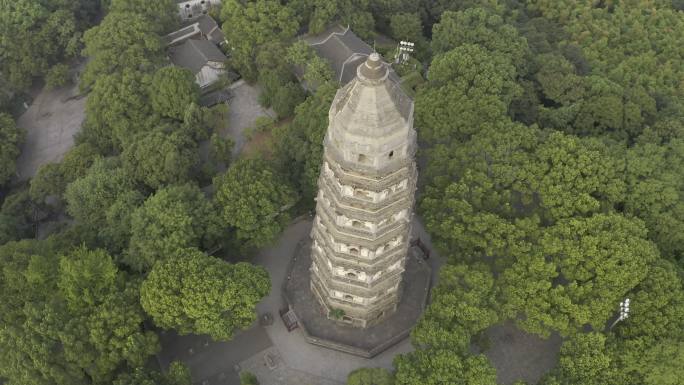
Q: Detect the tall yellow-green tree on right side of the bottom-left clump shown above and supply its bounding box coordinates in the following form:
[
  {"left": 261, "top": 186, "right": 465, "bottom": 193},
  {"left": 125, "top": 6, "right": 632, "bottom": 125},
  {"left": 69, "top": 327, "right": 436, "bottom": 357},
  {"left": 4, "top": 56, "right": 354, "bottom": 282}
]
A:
[{"left": 57, "top": 247, "right": 159, "bottom": 383}]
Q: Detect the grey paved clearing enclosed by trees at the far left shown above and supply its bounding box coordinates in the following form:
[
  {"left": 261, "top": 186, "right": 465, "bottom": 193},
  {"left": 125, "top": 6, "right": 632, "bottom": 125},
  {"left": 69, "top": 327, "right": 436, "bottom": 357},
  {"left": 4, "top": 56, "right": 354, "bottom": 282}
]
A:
[{"left": 17, "top": 79, "right": 86, "bottom": 181}]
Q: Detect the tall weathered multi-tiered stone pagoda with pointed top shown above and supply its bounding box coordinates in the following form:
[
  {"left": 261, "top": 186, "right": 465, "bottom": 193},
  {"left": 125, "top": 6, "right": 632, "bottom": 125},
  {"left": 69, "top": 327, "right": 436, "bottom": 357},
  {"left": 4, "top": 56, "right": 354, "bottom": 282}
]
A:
[{"left": 310, "top": 53, "right": 417, "bottom": 328}]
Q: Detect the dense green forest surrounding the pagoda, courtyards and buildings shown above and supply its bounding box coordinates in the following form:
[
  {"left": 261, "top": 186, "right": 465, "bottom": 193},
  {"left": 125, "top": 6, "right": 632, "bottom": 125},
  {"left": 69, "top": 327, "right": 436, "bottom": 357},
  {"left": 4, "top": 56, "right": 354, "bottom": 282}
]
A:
[{"left": 0, "top": 0, "right": 684, "bottom": 385}]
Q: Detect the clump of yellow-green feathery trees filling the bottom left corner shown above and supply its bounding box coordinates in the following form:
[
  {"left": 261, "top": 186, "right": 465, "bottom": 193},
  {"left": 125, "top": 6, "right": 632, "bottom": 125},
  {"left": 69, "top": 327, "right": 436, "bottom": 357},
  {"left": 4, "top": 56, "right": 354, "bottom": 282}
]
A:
[{"left": 0, "top": 240, "right": 159, "bottom": 385}]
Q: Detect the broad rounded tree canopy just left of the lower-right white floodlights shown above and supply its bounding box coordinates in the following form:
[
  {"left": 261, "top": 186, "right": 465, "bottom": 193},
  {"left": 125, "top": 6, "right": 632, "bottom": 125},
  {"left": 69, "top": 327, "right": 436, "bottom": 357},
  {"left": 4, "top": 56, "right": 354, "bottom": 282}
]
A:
[{"left": 500, "top": 214, "right": 659, "bottom": 334}]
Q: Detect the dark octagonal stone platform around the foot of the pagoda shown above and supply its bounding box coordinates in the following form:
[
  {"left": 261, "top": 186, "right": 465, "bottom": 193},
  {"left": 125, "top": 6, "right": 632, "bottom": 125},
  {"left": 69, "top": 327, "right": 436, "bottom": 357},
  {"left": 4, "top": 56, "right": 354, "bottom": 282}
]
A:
[{"left": 283, "top": 237, "right": 430, "bottom": 358}]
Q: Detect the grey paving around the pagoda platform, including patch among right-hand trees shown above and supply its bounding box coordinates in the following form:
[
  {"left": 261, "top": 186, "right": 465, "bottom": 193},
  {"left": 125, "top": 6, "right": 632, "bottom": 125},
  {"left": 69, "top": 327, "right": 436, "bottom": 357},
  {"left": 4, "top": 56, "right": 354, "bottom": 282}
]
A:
[{"left": 160, "top": 217, "right": 560, "bottom": 385}]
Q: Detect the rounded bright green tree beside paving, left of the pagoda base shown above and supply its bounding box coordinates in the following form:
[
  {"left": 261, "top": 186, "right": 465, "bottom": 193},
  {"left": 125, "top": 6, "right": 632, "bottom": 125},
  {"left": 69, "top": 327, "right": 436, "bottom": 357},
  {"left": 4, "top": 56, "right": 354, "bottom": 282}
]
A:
[{"left": 140, "top": 249, "right": 271, "bottom": 340}]
